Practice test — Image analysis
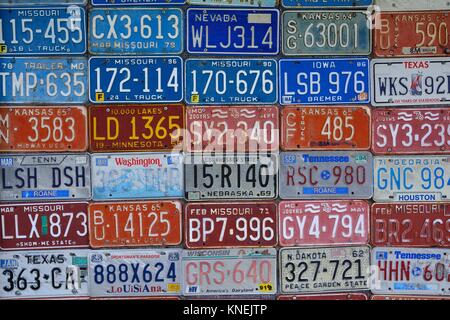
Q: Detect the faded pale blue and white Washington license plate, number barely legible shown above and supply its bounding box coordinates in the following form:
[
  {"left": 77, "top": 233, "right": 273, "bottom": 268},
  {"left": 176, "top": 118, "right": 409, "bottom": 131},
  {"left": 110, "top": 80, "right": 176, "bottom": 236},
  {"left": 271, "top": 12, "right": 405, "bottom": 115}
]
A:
[{"left": 91, "top": 153, "right": 183, "bottom": 200}]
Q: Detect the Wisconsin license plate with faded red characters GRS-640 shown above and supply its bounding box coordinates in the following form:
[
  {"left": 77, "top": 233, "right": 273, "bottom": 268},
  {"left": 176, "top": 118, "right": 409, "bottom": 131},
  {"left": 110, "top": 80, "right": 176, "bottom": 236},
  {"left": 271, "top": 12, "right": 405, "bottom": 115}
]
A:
[{"left": 182, "top": 248, "right": 277, "bottom": 296}]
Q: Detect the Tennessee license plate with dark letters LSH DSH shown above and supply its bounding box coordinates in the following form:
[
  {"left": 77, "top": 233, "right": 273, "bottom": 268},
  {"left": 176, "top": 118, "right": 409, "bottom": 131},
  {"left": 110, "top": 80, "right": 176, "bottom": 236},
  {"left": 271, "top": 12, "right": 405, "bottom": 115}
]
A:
[{"left": 0, "top": 153, "right": 91, "bottom": 201}]
